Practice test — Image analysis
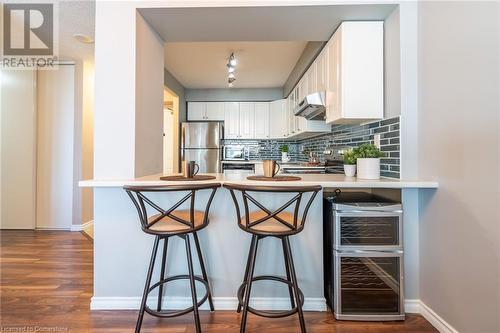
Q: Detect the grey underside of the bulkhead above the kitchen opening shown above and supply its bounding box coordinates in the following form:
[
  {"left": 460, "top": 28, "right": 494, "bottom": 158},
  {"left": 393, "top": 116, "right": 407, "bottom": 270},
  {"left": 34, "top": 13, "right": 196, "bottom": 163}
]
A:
[{"left": 139, "top": 4, "right": 396, "bottom": 42}]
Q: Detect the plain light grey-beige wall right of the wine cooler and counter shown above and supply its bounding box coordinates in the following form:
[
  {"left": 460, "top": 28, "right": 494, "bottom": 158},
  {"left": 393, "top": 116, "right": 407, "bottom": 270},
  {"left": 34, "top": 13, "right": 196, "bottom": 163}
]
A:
[{"left": 416, "top": 1, "right": 500, "bottom": 333}]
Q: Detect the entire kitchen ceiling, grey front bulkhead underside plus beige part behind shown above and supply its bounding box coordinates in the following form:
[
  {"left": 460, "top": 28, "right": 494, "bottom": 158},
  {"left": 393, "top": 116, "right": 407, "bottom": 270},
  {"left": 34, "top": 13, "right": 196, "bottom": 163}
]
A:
[{"left": 143, "top": 4, "right": 396, "bottom": 89}]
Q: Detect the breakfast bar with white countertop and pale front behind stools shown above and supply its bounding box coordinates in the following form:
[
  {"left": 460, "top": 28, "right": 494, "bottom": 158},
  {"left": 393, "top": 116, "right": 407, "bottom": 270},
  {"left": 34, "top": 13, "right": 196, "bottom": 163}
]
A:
[{"left": 80, "top": 174, "right": 438, "bottom": 316}]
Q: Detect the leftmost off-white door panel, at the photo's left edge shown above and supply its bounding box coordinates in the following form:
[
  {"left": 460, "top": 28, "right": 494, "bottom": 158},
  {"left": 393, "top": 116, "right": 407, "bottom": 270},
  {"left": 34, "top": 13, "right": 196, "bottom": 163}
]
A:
[{"left": 0, "top": 69, "right": 36, "bottom": 229}]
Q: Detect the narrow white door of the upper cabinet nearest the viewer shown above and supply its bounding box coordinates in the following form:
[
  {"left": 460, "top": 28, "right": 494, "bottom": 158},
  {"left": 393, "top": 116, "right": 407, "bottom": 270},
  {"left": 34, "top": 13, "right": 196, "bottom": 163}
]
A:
[{"left": 326, "top": 28, "right": 342, "bottom": 123}]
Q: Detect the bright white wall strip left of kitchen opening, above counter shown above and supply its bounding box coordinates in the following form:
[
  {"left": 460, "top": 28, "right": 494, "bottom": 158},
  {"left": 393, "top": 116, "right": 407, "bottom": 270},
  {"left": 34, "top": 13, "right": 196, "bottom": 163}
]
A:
[{"left": 94, "top": 1, "right": 137, "bottom": 179}]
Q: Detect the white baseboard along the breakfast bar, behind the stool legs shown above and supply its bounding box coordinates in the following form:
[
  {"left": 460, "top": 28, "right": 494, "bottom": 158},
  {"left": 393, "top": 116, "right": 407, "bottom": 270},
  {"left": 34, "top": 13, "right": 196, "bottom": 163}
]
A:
[{"left": 90, "top": 296, "right": 327, "bottom": 311}]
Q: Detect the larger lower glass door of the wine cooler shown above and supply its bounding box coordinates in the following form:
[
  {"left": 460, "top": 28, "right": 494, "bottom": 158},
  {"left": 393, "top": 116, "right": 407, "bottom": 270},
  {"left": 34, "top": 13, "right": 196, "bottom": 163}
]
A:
[{"left": 334, "top": 251, "right": 405, "bottom": 321}]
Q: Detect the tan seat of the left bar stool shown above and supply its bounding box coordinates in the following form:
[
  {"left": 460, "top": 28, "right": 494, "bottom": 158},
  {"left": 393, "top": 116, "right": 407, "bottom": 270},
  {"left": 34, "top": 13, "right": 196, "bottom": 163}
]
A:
[{"left": 148, "top": 210, "right": 205, "bottom": 234}]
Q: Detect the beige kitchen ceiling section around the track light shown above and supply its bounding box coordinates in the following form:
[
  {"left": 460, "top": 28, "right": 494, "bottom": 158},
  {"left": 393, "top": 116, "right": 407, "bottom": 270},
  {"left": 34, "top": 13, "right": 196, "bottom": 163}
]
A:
[{"left": 165, "top": 41, "right": 307, "bottom": 89}]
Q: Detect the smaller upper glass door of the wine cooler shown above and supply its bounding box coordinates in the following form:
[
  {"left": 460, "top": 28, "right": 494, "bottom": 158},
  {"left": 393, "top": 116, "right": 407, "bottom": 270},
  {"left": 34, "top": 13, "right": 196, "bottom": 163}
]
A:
[{"left": 333, "top": 211, "right": 403, "bottom": 251}]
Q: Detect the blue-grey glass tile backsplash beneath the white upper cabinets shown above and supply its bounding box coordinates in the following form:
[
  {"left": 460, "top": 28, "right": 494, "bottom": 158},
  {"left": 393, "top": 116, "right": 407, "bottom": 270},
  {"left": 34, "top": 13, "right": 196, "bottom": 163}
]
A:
[{"left": 224, "top": 117, "right": 400, "bottom": 178}]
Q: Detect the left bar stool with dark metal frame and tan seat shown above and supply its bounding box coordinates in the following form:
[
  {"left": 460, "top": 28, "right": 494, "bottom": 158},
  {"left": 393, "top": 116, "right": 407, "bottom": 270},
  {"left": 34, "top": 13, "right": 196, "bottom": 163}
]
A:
[{"left": 124, "top": 183, "right": 221, "bottom": 333}]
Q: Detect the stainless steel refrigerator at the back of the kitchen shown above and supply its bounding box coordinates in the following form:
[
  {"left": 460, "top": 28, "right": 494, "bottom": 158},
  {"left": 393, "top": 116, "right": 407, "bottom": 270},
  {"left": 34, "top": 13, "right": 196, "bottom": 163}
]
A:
[{"left": 180, "top": 122, "right": 224, "bottom": 173}]
